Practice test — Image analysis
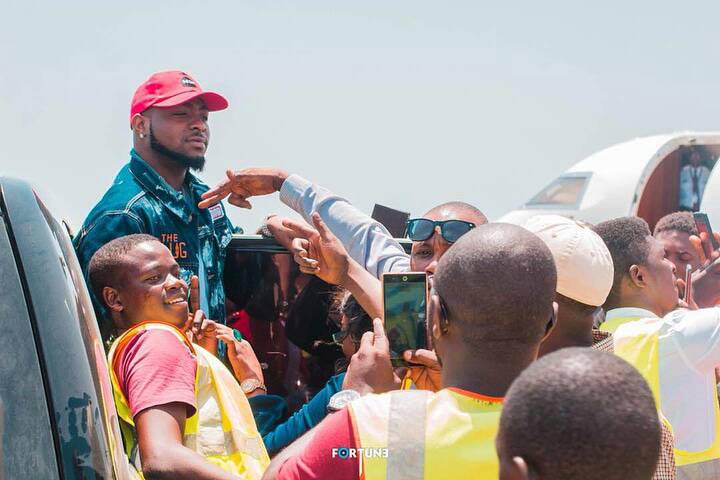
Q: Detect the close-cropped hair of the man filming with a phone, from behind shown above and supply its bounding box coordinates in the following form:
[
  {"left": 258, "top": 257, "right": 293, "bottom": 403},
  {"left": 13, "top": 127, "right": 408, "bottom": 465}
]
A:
[{"left": 434, "top": 223, "right": 557, "bottom": 351}]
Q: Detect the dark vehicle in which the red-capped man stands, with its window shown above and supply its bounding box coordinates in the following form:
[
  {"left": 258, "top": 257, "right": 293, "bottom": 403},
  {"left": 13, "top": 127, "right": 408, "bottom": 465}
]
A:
[{"left": 0, "top": 177, "right": 409, "bottom": 480}]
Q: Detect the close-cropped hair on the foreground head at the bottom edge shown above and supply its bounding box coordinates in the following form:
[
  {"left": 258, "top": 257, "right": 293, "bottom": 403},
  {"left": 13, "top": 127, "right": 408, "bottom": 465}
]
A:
[{"left": 497, "top": 347, "right": 661, "bottom": 480}]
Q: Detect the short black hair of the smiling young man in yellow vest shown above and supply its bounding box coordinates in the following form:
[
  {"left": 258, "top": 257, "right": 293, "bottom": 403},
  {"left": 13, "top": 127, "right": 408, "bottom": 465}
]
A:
[{"left": 88, "top": 233, "right": 161, "bottom": 306}]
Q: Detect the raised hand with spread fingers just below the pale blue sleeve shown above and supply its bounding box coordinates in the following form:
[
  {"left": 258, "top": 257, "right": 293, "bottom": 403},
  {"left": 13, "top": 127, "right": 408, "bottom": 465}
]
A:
[{"left": 283, "top": 212, "right": 350, "bottom": 285}]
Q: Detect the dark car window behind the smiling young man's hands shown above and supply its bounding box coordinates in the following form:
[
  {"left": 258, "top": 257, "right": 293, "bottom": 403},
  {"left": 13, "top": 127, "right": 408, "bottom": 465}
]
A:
[{"left": 224, "top": 241, "right": 342, "bottom": 412}]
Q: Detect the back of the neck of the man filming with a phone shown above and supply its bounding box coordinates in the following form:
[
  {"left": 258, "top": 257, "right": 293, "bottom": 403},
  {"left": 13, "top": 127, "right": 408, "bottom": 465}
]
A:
[{"left": 442, "top": 345, "right": 537, "bottom": 397}]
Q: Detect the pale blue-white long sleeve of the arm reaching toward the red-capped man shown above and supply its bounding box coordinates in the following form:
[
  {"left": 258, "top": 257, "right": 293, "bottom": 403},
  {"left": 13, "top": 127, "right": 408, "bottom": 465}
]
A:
[{"left": 280, "top": 175, "right": 410, "bottom": 278}]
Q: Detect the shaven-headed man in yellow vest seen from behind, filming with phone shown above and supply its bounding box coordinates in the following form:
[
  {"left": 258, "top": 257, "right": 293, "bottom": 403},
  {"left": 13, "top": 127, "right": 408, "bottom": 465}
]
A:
[{"left": 263, "top": 224, "right": 556, "bottom": 480}]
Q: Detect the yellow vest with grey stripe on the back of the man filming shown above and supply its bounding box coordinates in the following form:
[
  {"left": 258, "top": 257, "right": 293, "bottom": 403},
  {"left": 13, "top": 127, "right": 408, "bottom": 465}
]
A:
[{"left": 349, "top": 388, "right": 503, "bottom": 480}]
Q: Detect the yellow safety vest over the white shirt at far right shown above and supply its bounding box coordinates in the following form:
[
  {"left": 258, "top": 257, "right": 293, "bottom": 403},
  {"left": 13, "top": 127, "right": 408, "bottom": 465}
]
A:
[{"left": 613, "top": 318, "right": 720, "bottom": 480}]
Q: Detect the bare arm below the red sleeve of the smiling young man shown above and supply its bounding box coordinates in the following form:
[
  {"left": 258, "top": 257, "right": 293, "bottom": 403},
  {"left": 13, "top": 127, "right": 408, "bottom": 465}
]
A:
[{"left": 134, "top": 403, "right": 237, "bottom": 480}]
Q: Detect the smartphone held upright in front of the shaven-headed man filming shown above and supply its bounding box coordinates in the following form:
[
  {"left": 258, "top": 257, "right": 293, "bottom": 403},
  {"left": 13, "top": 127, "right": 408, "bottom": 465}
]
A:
[{"left": 382, "top": 273, "right": 427, "bottom": 366}]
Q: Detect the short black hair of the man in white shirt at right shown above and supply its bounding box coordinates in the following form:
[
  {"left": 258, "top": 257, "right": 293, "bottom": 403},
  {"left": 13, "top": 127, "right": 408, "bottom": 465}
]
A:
[{"left": 595, "top": 217, "right": 651, "bottom": 305}]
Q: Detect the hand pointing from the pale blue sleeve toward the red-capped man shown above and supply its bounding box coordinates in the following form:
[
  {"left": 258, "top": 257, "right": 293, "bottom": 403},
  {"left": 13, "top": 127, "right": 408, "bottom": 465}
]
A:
[{"left": 198, "top": 168, "right": 288, "bottom": 209}]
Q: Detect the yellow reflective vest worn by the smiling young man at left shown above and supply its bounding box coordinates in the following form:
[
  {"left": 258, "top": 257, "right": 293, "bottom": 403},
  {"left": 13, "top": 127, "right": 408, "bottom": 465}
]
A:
[{"left": 108, "top": 322, "right": 270, "bottom": 480}]
